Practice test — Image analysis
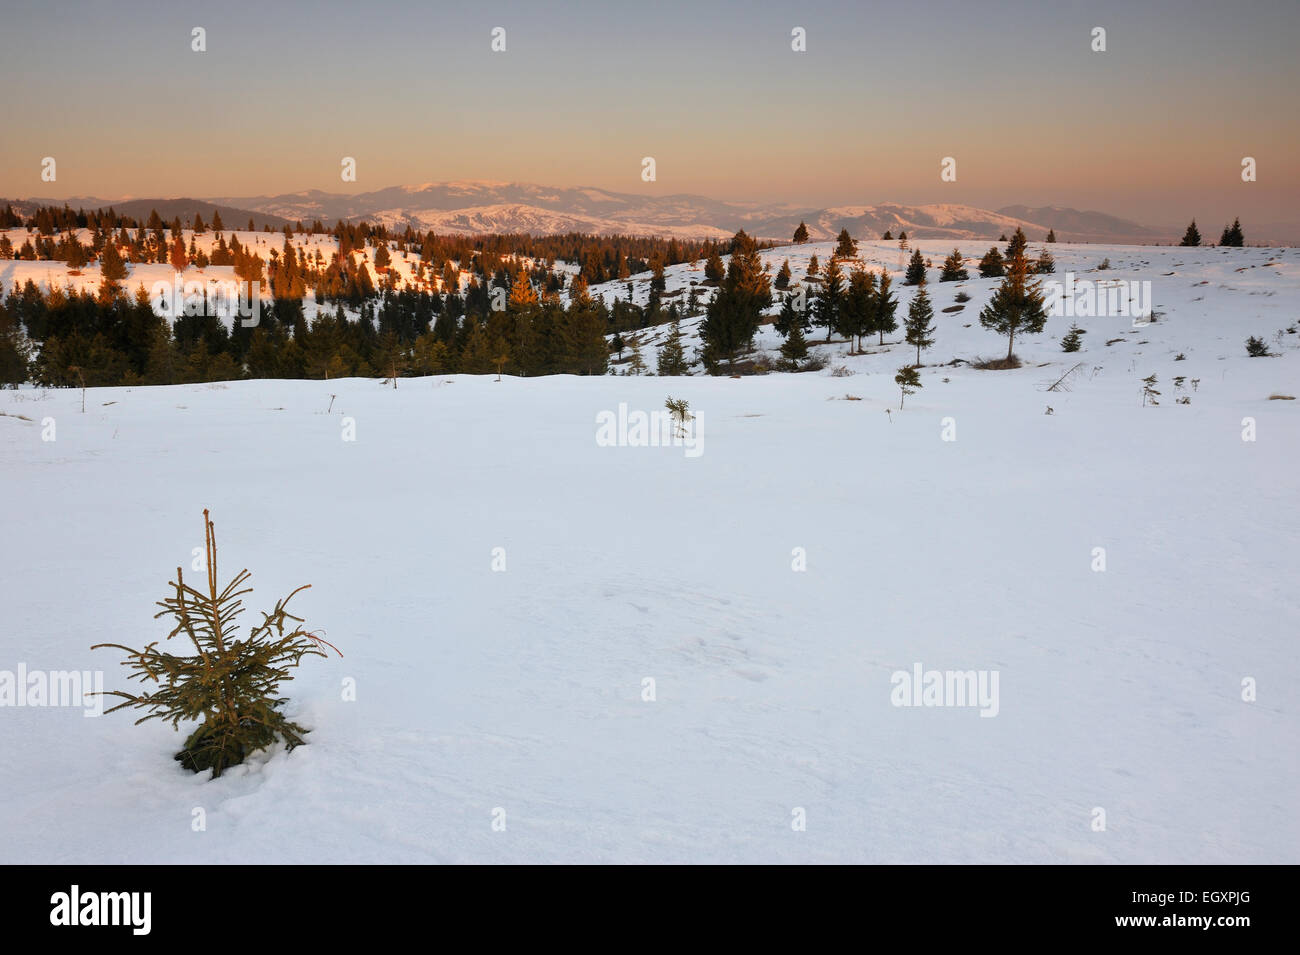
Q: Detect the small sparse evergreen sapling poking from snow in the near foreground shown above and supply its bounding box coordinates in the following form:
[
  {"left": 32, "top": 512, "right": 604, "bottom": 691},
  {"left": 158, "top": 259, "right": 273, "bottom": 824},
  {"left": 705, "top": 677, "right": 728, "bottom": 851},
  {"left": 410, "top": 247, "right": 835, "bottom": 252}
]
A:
[{"left": 91, "top": 511, "right": 337, "bottom": 777}]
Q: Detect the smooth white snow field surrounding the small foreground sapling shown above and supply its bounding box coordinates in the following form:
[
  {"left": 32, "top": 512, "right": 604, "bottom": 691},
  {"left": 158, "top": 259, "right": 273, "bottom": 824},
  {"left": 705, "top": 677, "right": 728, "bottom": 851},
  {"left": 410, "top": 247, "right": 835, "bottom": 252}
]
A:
[{"left": 0, "top": 242, "right": 1300, "bottom": 863}]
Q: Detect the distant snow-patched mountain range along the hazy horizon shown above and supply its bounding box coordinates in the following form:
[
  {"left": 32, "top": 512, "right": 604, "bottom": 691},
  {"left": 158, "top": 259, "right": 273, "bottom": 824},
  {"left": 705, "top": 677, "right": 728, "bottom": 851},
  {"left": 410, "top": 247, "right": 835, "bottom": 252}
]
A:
[{"left": 0, "top": 181, "right": 1206, "bottom": 243}]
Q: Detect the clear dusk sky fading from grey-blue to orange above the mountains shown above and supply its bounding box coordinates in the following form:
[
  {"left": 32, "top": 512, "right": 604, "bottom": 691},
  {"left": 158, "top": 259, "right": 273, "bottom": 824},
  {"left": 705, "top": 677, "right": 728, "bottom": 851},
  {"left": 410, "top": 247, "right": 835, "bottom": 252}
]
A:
[{"left": 0, "top": 0, "right": 1300, "bottom": 231}]
